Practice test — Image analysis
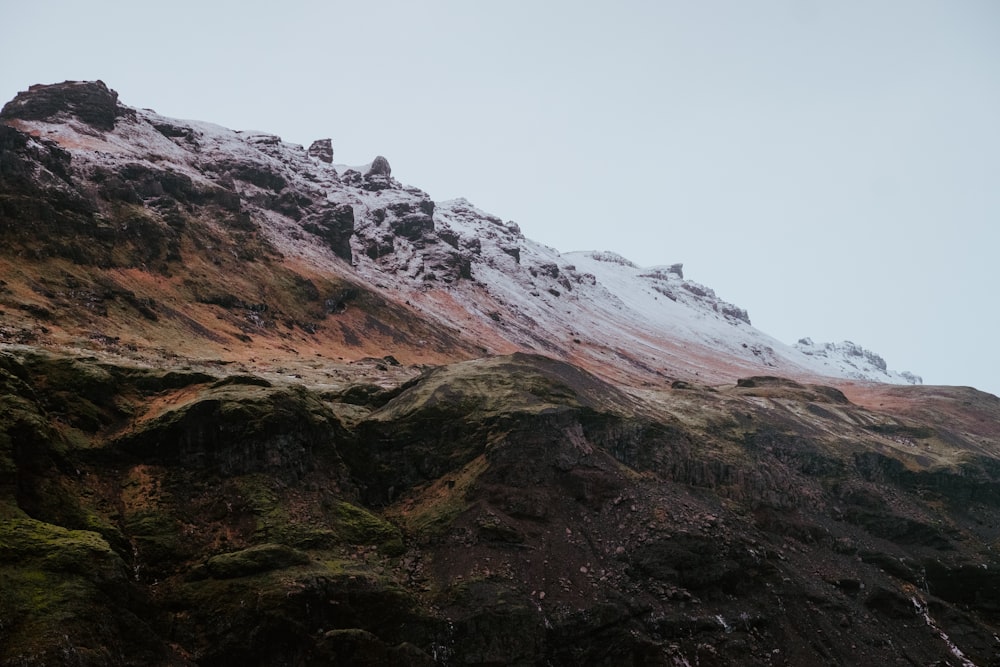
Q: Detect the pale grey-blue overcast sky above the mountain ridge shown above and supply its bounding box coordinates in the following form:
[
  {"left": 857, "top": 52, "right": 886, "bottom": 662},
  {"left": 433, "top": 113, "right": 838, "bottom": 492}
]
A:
[{"left": 0, "top": 0, "right": 1000, "bottom": 394}]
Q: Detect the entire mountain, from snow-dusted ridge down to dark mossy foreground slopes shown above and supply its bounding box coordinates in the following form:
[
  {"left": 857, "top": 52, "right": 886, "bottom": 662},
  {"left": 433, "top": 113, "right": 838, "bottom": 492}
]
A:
[{"left": 0, "top": 82, "right": 1000, "bottom": 667}]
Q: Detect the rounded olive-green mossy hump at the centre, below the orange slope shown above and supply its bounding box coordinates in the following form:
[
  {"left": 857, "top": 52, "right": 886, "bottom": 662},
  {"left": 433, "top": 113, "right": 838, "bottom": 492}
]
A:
[{"left": 341, "top": 354, "right": 636, "bottom": 506}]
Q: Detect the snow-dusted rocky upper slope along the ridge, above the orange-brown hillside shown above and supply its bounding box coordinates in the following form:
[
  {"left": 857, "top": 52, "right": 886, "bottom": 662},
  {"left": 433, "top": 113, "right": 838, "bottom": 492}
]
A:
[{"left": 4, "top": 82, "right": 919, "bottom": 383}]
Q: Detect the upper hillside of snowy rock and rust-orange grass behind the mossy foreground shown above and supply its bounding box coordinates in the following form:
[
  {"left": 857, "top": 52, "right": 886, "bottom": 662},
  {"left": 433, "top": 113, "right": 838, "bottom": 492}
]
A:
[{"left": 0, "top": 82, "right": 916, "bottom": 384}]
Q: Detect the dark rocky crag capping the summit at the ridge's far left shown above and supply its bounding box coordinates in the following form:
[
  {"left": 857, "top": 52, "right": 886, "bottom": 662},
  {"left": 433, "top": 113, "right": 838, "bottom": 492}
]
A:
[{"left": 0, "top": 81, "right": 131, "bottom": 131}]
